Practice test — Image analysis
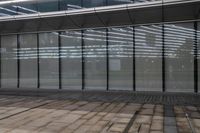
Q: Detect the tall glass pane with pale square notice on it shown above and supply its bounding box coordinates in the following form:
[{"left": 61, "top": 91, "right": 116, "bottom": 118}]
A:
[{"left": 108, "top": 27, "right": 133, "bottom": 90}]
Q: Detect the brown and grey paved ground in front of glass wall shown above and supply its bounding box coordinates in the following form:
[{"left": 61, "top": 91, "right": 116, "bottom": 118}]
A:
[{"left": 0, "top": 92, "right": 200, "bottom": 133}]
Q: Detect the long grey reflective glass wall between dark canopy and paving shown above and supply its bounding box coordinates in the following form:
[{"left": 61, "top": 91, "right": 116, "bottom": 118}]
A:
[{"left": 0, "top": 22, "right": 200, "bottom": 92}]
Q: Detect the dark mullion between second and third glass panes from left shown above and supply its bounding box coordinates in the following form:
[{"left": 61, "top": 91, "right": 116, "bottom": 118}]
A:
[{"left": 36, "top": 33, "right": 40, "bottom": 88}]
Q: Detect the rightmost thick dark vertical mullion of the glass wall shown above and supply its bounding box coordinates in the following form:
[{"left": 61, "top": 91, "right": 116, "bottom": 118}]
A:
[{"left": 193, "top": 21, "right": 198, "bottom": 93}]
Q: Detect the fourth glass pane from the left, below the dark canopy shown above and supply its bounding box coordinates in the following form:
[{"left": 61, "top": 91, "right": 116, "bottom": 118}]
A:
[{"left": 61, "top": 31, "right": 82, "bottom": 90}]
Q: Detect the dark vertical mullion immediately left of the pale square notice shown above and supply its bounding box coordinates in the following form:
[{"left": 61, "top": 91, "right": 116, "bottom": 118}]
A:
[{"left": 106, "top": 28, "right": 109, "bottom": 91}]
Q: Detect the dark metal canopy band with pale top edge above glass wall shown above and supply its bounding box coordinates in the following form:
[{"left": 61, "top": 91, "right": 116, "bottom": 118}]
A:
[{"left": 0, "top": 0, "right": 200, "bottom": 34}]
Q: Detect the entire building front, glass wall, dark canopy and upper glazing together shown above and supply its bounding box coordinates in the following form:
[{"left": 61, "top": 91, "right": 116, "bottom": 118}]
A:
[{"left": 0, "top": 0, "right": 200, "bottom": 93}]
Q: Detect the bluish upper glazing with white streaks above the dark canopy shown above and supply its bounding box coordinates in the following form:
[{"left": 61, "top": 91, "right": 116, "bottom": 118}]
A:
[{"left": 0, "top": 0, "right": 160, "bottom": 16}]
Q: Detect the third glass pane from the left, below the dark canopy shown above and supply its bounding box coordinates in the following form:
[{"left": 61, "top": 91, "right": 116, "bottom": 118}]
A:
[{"left": 39, "top": 32, "right": 59, "bottom": 89}]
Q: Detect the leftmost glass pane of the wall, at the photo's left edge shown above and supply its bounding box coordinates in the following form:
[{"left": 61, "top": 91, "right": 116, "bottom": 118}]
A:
[{"left": 1, "top": 35, "right": 18, "bottom": 88}]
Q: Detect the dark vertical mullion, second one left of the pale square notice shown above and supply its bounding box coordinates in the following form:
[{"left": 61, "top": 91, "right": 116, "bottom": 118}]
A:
[{"left": 81, "top": 30, "right": 85, "bottom": 90}]
